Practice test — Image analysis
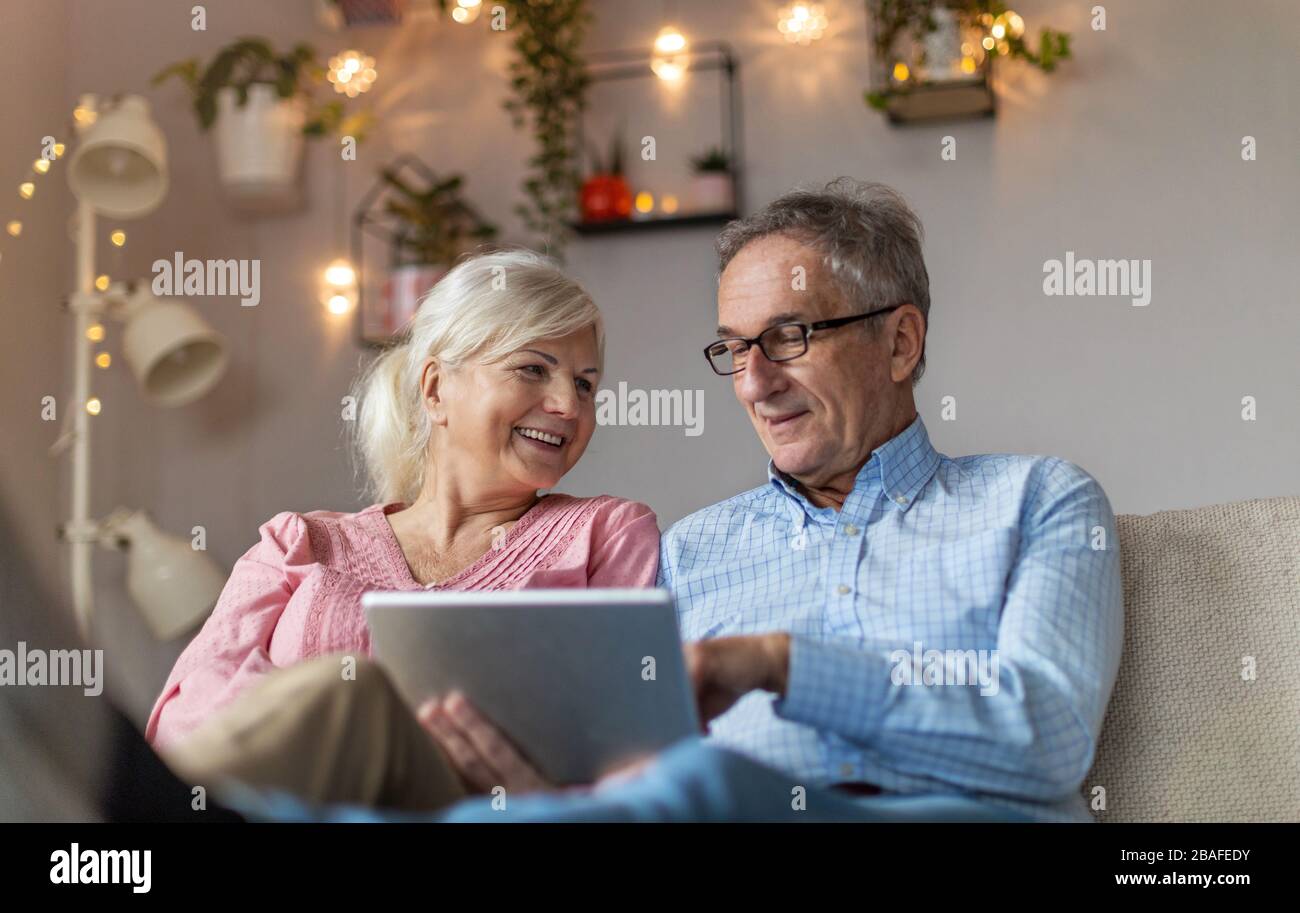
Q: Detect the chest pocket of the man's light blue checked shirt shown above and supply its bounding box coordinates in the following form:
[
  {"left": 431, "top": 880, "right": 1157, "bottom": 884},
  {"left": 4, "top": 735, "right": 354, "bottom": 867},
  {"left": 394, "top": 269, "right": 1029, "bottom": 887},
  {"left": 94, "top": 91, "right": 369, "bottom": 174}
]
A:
[{"left": 857, "top": 527, "right": 1021, "bottom": 648}]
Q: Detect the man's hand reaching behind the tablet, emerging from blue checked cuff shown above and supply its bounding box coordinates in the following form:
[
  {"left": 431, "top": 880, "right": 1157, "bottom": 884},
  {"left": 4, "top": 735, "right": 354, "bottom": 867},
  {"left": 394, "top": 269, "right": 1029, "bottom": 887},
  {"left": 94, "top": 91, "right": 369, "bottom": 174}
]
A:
[{"left": 684, "top": 633, "right": 790, "bottom": 731}]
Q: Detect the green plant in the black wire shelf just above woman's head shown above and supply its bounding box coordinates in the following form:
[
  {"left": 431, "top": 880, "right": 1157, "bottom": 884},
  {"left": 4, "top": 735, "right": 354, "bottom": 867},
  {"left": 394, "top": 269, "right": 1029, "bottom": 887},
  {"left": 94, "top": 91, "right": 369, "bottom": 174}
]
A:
[{"left": 380, "top": 168, "right": 497, "bottom": 267}]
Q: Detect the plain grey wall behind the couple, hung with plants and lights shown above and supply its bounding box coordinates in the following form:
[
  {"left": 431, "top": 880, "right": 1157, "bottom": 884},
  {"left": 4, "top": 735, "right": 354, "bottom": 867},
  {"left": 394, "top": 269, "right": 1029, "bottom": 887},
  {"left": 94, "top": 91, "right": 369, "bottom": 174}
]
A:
[{"left": 0, "top": 0, "right": 1300, "bottom": 718}]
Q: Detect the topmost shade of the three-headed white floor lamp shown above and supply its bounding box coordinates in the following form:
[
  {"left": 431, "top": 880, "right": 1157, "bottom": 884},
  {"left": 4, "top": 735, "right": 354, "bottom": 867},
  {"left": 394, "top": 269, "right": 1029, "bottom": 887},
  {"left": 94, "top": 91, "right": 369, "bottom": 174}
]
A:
[{"left": 68, "top": 95, "right": 168, "bottom": 218}]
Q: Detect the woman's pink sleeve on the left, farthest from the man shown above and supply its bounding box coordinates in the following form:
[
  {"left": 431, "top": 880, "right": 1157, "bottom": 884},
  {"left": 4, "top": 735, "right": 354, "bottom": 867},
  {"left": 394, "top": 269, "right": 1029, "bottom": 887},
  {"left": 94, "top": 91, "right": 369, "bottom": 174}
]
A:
[{"left": 144, "top": 511, "right": 315, "bottom": 748}]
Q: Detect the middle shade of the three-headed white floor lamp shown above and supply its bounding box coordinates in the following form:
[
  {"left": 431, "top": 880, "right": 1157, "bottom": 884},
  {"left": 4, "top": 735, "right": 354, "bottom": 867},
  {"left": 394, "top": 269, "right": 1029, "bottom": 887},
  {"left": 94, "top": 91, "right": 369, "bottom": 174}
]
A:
[{"left": 122, "top": 286, "right": 229, "bottom": 406}]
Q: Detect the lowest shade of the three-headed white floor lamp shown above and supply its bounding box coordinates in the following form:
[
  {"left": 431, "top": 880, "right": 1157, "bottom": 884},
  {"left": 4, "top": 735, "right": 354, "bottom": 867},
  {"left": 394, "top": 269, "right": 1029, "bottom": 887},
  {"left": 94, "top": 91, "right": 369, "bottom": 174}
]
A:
[{"left": 114, "top": 511, "right": 225, "bottom": 640}]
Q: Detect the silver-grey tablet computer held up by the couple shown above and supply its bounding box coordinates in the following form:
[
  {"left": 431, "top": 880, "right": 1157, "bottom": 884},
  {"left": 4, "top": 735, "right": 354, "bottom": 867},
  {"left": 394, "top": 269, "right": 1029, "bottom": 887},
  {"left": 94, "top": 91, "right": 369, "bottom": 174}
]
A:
[{"left": 361, "top": 589, "right": 699, "bottom": 786}]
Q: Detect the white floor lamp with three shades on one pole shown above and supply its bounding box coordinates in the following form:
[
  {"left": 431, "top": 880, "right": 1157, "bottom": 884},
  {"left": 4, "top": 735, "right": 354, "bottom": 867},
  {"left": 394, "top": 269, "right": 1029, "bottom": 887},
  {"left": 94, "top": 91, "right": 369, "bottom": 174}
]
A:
[{"left": 51, "top": 95, "right": 228, "bottom": 640}]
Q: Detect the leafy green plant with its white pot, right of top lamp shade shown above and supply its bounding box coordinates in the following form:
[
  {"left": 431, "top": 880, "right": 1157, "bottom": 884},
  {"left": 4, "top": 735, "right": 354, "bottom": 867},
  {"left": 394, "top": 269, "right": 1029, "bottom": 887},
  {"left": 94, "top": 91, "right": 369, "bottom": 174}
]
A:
[{"left": 152, "top": 38, "right": 372, "bottom": 211}]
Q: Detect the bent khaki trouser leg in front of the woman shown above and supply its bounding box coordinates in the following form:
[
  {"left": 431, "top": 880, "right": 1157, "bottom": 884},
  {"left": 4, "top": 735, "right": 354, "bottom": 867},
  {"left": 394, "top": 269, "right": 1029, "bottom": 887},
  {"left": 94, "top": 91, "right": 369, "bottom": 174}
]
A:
[{"left": 163, "top": 655, "right": 467, "bottom": 812}]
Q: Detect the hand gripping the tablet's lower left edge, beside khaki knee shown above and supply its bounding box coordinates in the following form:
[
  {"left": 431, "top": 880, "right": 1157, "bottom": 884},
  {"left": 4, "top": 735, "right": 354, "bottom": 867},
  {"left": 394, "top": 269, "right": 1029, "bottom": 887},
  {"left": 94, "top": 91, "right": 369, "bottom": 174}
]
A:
[{"left": 416, "top": 692, "right": 555, "bottom": 793}]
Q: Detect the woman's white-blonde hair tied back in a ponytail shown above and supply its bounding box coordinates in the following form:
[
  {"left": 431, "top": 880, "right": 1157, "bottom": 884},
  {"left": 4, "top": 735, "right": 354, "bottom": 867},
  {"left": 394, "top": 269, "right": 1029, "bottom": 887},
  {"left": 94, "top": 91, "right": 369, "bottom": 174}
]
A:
[{"left": 352, "top": 250, "right": 605, "bottom": 503}]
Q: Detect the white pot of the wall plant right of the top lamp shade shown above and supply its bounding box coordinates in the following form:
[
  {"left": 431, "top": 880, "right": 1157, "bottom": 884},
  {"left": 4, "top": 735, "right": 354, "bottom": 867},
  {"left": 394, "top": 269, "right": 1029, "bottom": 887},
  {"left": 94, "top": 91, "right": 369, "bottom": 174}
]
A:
[{"left": 213, "top": 83, "right": 306, "bottom": 211}]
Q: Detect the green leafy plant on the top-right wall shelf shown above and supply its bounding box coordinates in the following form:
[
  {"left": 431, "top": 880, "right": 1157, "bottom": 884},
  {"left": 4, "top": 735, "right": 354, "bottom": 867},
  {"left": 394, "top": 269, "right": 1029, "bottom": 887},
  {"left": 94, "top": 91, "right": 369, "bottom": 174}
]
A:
[{"left": 866, "top": 0, "right": 1071, "bottom": 111}]
